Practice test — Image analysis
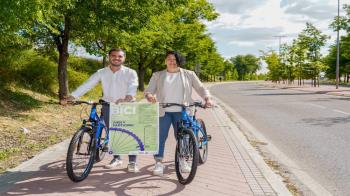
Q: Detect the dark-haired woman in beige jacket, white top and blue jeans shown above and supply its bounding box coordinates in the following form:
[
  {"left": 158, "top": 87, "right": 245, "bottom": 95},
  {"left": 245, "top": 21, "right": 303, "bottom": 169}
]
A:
[{"left": 145, "top": 51, "right": 212, "bottom": 175}]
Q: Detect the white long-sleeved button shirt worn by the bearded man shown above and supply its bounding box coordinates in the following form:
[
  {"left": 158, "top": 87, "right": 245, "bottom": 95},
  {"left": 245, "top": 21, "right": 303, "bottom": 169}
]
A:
[{"left": 71, "top": 66, "right": 138, "bottom": 102}]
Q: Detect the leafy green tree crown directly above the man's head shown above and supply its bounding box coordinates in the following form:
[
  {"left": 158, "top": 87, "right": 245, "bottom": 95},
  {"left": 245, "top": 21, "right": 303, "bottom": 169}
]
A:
[{"left": 76, "top": 0, "right": 170, "bottom": 67}]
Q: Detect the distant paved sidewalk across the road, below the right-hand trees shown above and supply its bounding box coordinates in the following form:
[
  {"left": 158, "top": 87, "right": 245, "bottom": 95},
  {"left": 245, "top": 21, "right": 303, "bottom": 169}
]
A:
[{"left": 262, "top": 82, "right": 350, "bottom": 97}]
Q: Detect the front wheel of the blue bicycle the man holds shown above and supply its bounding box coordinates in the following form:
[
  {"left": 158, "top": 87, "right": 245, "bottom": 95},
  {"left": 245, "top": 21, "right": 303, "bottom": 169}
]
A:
[{"left": 66, "top": 127, "right": 95, "bottom": 182}]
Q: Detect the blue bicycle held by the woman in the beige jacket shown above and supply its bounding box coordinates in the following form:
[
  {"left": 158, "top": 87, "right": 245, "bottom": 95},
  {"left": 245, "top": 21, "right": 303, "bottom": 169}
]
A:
[{"left": 160, "top": 102, "right": 211, "bottom": 185}]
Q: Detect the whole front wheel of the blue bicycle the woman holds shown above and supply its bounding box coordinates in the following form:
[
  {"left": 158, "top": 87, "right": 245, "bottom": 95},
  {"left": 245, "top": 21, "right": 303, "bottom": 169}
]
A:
[{"left": 175, "top": 129, "right": 199, "bottom": 185}]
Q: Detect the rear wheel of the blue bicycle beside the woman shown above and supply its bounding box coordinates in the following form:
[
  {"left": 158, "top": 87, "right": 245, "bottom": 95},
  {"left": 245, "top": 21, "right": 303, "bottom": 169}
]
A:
[{"left": 197, "top": 119, "right": 208, "bottom": 164}]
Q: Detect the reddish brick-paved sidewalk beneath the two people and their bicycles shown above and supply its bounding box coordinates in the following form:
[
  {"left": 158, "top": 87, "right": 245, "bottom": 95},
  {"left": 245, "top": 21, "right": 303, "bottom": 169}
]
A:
[{"left": 0, "top": 92, "right": 290, "bottom": 196}]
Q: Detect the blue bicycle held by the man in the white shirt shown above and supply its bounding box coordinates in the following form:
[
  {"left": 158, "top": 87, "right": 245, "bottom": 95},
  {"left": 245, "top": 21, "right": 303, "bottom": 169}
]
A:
[{"left": 66, "top": 100, "right": 109, "bottom": 182}]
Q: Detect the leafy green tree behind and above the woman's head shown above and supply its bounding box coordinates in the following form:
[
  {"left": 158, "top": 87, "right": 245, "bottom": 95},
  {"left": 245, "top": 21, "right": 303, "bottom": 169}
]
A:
[{"left": 124, "top": 0, "right": 217, "bottom": 90}]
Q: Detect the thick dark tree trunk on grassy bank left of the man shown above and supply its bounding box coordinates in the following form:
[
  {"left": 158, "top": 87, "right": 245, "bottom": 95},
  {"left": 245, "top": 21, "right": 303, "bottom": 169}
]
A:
[{"left": 56, "top": 16, "right": 71, "bottom": 100}]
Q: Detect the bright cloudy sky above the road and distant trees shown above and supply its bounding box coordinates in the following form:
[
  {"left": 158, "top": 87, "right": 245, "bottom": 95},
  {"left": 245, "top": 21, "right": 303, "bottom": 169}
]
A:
[{"left": 205, "top": 0, "right": 350, "bottom": 61}]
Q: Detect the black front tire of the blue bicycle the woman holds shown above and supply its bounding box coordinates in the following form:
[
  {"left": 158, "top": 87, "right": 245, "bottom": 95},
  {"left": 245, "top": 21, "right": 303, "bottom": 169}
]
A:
[{"left": 175, "top": 129, "right": 199, "bottom": 185}]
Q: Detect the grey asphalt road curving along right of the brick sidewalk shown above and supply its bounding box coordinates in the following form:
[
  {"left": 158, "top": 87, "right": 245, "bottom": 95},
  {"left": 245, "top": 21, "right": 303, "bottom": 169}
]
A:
[{"left": 210, "top": 83, "right": 350, "bottom": 195}]
